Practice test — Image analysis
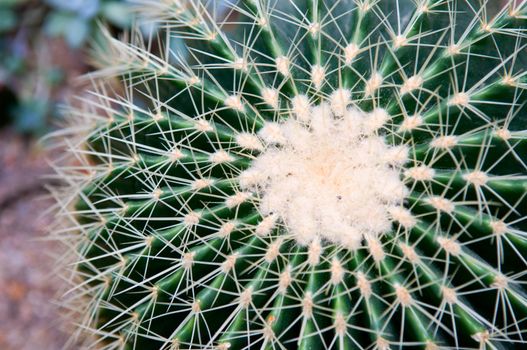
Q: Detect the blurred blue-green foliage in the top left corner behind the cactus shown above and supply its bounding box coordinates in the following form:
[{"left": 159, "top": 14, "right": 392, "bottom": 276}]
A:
[{"left": 0, "top": 0, "right": 132, "bottom": 134}]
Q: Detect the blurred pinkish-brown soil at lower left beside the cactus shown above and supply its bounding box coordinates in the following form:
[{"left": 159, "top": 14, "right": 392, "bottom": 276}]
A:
[{"left": 0, "top": 131, "right": 73, "bottom": 350}]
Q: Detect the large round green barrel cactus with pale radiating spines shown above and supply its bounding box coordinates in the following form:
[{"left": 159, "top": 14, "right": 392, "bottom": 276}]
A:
[{"left": 55, "top": 0, "right": 527, "bottom": 350}]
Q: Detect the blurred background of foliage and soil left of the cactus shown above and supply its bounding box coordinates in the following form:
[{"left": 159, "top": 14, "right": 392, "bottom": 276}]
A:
[{"left": 0, "top": 0, "right": 524, "bottom": 350}]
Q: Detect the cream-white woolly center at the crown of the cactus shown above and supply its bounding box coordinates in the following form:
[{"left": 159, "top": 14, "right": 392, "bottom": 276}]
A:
[{"left": 240, "top": 104, "right": 408, "bottom": 249}]
